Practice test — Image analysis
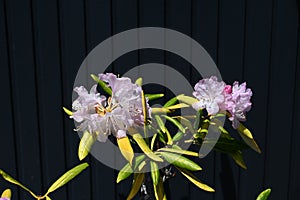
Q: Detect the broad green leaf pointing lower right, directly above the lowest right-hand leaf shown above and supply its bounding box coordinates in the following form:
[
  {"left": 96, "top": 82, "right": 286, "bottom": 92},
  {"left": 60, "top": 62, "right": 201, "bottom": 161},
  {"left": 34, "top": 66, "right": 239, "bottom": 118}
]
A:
[{"left": 159, "top": 152, "right": 202, "bottom": 171}]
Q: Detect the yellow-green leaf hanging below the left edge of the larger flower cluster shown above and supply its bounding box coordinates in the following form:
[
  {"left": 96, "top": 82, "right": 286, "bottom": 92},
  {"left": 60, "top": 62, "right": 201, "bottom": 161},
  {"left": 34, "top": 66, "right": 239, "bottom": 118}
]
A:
[{"left": 78, "top": 131, "right": 96, "bottom": 160}]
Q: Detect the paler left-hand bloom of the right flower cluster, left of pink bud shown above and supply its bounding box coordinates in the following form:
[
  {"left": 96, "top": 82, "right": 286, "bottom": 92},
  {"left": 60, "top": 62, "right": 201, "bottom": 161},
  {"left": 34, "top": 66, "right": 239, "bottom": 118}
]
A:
[{"left": 192, "top": 76, "right": 225, "bottom": 115}]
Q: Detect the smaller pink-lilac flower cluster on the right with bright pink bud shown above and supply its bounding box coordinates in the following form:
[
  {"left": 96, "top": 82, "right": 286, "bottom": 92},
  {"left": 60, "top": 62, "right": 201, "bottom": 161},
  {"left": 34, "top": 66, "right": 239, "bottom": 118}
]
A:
[{"left": 193, "top": 76, "right": 252, "bottom": 129}]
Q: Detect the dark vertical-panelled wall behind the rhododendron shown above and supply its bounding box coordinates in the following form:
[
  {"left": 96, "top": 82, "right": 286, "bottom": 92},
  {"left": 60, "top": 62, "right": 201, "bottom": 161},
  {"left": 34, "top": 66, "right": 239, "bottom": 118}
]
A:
[{"left": 0, "top": 0, "right": 300, "bottom": 200}]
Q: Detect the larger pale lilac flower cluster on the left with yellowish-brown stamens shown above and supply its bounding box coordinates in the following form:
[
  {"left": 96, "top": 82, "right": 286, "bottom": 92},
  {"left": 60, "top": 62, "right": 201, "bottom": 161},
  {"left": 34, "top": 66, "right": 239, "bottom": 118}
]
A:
[{"left": 71, "top": 73, "right": 150, "bottom": 142}]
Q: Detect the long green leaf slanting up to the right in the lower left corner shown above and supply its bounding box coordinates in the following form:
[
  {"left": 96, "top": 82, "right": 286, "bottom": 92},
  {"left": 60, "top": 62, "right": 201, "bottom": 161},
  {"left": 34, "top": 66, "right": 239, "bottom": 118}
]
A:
[{"left": 47, "top": 163, "right": 89, "bottom": 194}]
